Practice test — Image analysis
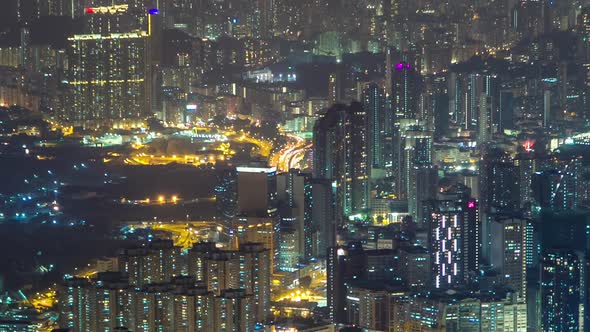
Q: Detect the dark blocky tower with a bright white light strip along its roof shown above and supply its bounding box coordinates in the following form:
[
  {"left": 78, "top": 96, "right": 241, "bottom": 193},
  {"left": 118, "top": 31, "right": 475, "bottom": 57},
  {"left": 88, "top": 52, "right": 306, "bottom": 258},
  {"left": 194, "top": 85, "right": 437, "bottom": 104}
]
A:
[{"left": 236, "top": 167, "right": 278, "bottom": 217}]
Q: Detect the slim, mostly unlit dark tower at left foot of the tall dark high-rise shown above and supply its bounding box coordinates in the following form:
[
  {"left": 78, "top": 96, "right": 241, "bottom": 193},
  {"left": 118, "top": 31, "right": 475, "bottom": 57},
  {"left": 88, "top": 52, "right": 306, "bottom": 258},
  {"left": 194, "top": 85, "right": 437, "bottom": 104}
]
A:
[{"left": 311, "top": 179, "right": 337, "bottom": 258}]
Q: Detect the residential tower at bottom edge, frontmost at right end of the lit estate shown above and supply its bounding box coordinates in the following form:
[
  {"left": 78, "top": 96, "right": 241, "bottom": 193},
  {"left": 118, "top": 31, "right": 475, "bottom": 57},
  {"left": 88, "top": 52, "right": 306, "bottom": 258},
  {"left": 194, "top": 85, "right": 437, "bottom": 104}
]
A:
[{"left": 212, "top": 289, "right": 256, "bottom": 332}]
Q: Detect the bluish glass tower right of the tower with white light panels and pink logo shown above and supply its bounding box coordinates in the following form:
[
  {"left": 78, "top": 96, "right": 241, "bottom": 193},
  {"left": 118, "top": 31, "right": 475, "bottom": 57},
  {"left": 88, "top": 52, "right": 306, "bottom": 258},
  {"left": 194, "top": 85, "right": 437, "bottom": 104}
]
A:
[{"left": 490, "top": 218, "right": 535, "bottom": 300}]
